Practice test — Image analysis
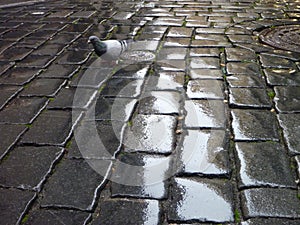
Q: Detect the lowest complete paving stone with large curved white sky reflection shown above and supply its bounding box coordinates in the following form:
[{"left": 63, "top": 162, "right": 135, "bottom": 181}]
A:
[{"left": 168, "top": 178, "right": 233, "bottom": 222}]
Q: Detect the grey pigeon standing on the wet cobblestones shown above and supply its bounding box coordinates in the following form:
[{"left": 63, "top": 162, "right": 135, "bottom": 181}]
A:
[{"left": 88, "top": 36, "right": 132, "bottom": 61}]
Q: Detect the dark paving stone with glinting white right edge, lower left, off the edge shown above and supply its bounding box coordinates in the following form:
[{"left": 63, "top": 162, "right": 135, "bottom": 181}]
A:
[{"left": 41, "top": 159, "right": 110, "bottom": 210}]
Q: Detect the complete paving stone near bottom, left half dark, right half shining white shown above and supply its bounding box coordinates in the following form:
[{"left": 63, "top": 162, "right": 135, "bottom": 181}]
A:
[{"left": 112, "top": 154, "right": 170, "bottom": 199}]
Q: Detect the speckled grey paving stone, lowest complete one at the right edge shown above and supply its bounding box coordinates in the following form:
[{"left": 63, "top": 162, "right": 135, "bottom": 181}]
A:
[{"left": 242, "top": 188, "right": 300, "bottom": 218}]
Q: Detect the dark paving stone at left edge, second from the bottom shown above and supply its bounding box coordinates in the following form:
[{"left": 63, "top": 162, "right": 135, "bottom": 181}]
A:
[{"left": 0, "top": 147, "right": 63, "bottom": 190}]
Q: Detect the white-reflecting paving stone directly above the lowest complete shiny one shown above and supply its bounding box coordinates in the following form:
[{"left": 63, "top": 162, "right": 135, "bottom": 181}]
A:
[{"left": 177, "top": 130, "right": 230, "bottom": 176}]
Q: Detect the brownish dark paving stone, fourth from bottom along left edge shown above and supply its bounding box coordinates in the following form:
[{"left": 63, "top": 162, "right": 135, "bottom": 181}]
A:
[{"left": 0, "top": 98, "right": 47, "bottom": 124}]
